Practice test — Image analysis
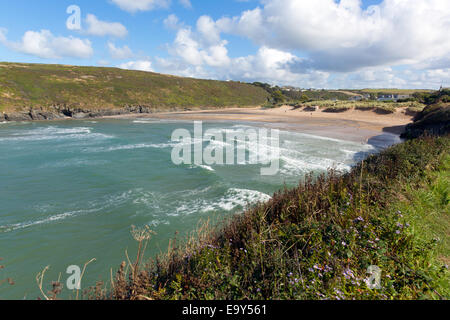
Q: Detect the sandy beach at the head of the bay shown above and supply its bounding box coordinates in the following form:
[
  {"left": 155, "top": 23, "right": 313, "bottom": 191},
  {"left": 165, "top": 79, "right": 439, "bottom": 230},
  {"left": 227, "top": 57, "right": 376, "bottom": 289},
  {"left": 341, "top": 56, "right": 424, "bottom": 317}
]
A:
[{"left": 108, "top": 106, "right": 413, "bottom": 143}]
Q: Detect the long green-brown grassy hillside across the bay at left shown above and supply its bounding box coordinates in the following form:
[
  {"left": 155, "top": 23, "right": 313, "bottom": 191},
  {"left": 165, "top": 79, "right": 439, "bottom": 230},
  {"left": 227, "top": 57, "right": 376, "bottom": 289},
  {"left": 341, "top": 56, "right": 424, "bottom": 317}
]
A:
[{"left": 0, "top": 63, "right": 268, "bottom": 111}]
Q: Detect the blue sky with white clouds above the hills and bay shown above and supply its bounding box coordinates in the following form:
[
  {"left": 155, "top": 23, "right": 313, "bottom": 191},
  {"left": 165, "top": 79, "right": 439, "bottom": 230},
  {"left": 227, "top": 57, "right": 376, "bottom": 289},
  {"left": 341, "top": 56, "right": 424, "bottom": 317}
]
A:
[{"left": 0, "top": 0, "right": 450, "bottom": 89}]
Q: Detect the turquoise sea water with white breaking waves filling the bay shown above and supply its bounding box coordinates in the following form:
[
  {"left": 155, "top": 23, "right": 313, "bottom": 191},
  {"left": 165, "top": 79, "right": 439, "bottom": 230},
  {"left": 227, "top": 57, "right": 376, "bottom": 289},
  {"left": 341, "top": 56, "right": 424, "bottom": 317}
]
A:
[{"left": 0, "top": 119, "right": 398, "bottom": 299}]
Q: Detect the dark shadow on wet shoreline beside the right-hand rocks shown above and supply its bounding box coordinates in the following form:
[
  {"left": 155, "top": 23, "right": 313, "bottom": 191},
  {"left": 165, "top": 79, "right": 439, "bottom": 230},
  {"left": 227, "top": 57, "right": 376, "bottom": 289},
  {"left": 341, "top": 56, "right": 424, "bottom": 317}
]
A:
[{"left": 353, "top": 126, "right": 405, "bottom": 163}]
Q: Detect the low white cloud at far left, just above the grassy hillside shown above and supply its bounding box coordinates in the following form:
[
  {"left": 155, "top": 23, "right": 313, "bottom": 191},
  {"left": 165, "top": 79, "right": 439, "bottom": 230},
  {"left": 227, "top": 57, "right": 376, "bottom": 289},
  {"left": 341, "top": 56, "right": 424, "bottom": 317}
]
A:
[{"left": 0, "top": 30, "right": 94, "bottom": 59}]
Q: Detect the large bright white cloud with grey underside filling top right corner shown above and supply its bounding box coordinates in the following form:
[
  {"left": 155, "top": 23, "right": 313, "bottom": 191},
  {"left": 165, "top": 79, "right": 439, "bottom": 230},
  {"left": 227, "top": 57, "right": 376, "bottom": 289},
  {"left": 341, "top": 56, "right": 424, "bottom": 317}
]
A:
[{"left": 216, "top": 0, "right": 450, "bottom": 72}]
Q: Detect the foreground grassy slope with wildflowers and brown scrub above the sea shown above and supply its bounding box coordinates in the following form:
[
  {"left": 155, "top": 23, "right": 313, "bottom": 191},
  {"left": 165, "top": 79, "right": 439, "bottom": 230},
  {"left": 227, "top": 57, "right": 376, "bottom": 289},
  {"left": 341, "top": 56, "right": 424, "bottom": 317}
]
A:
[{"left": 81, "top": 106, "right": 450, "bottom": 300}]
